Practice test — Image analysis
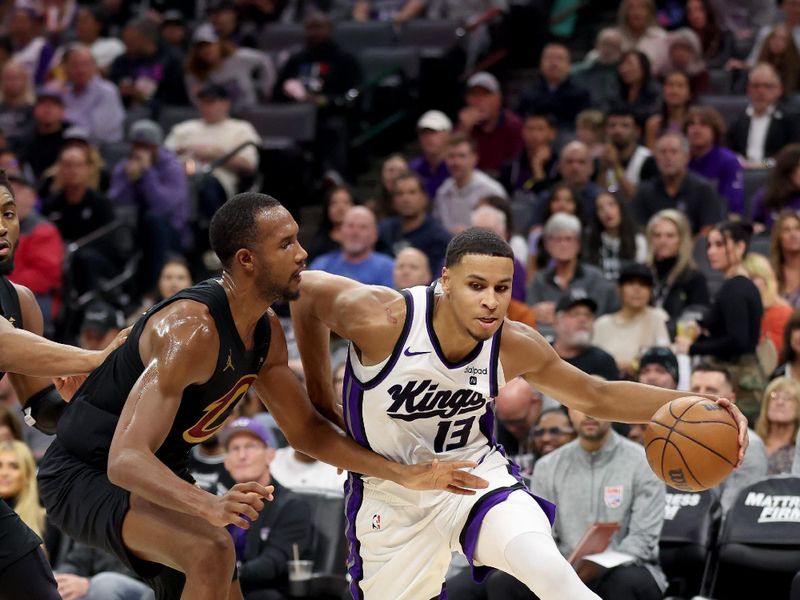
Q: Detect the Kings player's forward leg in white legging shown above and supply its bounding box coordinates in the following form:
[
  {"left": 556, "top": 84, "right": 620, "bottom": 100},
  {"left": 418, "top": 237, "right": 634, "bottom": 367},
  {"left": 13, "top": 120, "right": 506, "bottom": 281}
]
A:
[{"left": 475, "top": 490, "right": 600, "bottom": 600}]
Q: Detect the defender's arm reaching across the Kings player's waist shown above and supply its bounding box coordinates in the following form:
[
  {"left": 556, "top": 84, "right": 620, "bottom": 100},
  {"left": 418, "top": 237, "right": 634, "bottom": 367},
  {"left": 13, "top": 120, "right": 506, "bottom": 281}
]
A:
[{"left": 254, "top": 312, "right": 487, "bottom": 494}]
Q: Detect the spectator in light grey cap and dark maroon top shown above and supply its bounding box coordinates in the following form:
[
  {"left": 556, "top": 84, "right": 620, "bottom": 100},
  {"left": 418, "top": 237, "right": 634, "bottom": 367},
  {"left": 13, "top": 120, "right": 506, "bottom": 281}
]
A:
[{"left": 458, "top": 71, "right": 522, "bottom": 177}]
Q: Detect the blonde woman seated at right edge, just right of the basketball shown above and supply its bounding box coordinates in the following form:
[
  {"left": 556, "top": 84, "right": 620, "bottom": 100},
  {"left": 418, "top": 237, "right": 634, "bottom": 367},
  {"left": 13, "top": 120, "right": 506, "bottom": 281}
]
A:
[{"left": 755, "top": 377, "right": 800, "bottom": 475}]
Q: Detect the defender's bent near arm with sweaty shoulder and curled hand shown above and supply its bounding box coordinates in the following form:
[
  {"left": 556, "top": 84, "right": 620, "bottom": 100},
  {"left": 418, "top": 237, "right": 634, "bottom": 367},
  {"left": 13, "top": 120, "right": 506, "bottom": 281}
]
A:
[{"left": 108, "top": 301, "right": 272, "bottom": 528}]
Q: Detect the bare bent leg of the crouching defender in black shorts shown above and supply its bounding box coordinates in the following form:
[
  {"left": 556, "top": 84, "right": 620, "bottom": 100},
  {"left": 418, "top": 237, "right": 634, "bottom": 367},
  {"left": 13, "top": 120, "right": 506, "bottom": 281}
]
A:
[{"left": 122, "top": 494, "right": 236, "bottom": 600}]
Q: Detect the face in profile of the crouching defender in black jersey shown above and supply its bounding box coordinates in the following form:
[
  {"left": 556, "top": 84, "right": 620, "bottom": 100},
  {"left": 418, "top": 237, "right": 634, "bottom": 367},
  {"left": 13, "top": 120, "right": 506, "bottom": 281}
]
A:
[{"left": 253, "top": 208, "right": 308, "bottom": 300}]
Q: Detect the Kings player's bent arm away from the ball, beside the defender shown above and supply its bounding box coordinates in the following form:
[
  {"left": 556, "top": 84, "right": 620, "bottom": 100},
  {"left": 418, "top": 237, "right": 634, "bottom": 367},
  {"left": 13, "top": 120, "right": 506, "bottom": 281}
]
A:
[{"left": 291, "top": 271, "right": 405, "bottom": 428}]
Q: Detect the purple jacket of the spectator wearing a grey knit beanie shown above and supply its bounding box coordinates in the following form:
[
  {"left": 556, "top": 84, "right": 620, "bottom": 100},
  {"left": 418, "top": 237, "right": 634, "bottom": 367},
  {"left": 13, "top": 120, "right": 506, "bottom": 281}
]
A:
[{"left": 108, "top": 148, "right": 189, "bottom": 240}]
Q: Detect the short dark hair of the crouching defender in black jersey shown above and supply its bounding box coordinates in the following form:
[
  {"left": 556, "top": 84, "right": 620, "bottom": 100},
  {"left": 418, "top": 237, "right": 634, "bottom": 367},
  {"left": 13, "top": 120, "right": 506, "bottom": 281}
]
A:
[{"left": 208, "top": 192, "right": 281, "bottom": 267}]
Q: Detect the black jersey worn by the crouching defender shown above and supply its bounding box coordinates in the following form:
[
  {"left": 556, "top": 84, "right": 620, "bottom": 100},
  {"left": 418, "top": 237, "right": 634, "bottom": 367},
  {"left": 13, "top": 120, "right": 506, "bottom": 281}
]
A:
[{"left": 56, "top": 279, "right": 270, "bottom": 473}]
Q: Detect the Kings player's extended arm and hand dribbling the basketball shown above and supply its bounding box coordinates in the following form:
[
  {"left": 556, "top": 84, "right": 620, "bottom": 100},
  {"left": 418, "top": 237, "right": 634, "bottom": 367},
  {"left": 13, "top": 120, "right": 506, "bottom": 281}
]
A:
[{"left": 500, "top": 320, "right": 748, "bottom": 462}]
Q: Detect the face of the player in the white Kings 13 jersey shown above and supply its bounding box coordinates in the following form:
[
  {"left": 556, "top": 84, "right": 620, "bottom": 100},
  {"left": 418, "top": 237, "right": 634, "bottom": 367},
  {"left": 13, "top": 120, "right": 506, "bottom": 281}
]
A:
[{"left": 442, "top": 254, "right": 514, "bottom": 342}]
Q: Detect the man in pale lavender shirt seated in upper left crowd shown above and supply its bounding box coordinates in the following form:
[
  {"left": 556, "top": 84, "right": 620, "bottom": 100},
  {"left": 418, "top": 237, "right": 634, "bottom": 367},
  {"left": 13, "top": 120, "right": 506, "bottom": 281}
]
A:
[{"left": 63, "top": 44, "right": 125, "bottom": 144}]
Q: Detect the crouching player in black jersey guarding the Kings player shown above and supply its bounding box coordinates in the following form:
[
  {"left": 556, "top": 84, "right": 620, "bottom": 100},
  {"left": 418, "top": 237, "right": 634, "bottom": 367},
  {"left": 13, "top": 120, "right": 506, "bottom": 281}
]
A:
[{"left": 39, "top": 194, "right": 485, "bottom": 600}]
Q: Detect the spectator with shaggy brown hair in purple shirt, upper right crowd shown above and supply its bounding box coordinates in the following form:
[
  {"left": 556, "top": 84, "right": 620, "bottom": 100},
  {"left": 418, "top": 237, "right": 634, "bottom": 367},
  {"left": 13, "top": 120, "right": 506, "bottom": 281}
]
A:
[{"left": 684, "top": 106, "right": 744, "bottom": 215}]
